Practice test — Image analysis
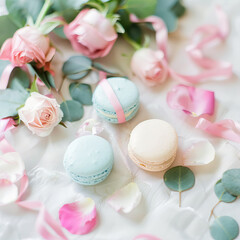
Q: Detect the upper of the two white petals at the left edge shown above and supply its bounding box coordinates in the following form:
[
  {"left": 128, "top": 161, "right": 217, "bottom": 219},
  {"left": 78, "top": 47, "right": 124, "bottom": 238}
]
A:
[{"left": 0, "top": 152, "right": 25, "bottom": 183}]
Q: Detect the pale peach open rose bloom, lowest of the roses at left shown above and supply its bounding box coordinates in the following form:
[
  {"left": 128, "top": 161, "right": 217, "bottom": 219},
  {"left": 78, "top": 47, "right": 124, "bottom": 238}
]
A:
[{"left": 18, "top": 92, "right": 63, "bottom": 137}]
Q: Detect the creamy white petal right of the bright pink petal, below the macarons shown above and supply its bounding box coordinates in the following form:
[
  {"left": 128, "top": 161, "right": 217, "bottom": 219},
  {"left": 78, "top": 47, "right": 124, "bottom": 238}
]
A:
[{"left": 107, "top": 182, "right": 142, "bottom": 213}]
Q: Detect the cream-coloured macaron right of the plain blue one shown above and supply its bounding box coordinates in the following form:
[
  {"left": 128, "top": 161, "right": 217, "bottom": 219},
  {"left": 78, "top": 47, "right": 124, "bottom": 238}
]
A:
[{"left": 128, "top": 119, "right": 178, "bottom": 172}]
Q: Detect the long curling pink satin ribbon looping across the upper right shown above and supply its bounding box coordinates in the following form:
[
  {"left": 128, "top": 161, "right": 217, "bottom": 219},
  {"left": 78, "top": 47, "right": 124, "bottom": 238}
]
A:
[{"left": 130, "top": 7, "right": 232, "bottom": 84}]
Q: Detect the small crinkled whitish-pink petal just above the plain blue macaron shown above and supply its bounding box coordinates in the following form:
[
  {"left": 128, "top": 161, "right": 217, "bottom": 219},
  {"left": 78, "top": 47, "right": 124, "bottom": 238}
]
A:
[{"left": 77, "top": 118, "right": 104, "bottom": 137}]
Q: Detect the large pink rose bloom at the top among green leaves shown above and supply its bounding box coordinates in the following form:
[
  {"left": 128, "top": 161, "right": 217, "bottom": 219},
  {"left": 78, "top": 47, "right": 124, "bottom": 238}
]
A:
[{"left": 64, "top": 9, "right": 117, "bottom": 59}]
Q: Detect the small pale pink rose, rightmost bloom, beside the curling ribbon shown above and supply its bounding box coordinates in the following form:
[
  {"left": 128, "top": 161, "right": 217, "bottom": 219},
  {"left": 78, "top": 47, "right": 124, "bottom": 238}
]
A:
[{"left": 131, "top": 48, "right": 168, "bottom": 86}]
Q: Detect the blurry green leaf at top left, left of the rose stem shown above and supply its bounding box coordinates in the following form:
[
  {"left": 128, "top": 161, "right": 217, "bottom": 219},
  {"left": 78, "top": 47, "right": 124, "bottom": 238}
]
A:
[{"left": 6, "top": 0, "right": 44, "bottom": 28}]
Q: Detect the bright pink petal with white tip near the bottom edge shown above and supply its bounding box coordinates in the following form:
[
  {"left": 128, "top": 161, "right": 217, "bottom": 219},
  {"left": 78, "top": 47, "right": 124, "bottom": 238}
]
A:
[{"left": 59, "top": 198, "right": 97, "bottom": 235}]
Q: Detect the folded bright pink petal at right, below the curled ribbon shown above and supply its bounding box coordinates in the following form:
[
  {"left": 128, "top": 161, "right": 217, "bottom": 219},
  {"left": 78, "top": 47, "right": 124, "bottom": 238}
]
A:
[{"left": 167, "top": 84, "right": 215, "bottom": 117}]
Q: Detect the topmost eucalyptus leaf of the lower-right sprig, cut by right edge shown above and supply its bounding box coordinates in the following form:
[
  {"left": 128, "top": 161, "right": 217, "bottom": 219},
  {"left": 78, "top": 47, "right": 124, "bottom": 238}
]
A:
[{"left": 222, "top": 168, "right": 240, "bottom": 196}]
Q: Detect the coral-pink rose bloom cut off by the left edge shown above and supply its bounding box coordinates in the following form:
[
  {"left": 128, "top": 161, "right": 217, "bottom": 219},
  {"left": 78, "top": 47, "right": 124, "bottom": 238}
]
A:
[{"left": 0, "top": 27, "right": 56, "bottom": 70}]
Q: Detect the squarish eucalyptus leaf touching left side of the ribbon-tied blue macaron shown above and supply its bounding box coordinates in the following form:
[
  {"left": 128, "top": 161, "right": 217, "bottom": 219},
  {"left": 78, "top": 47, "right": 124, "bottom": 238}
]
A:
[{"left": 69, "top": 83, "right": 92, "bottom": 105}]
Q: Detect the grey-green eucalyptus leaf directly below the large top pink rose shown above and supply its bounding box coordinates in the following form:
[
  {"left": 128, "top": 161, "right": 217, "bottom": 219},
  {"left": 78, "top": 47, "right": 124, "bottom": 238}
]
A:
[{"left": 62, "top": 56, "right": 92, "bottom": 80}]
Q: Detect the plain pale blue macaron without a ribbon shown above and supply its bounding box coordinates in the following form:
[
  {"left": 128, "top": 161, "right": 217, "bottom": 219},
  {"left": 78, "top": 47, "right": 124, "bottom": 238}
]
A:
[{"left": 63, "top": 135, "right": 114, "bottom": 185}]
